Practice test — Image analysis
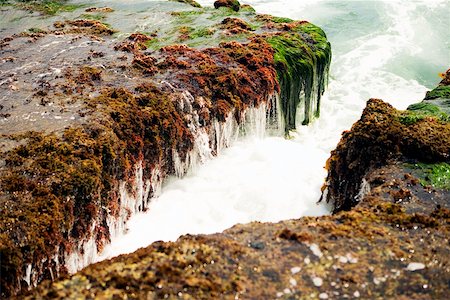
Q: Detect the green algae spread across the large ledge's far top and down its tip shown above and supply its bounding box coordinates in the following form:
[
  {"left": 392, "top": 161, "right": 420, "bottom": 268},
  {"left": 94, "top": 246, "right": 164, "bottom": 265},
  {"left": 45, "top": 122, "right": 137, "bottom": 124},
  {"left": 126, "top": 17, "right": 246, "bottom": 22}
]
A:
[{"left": 167, "top": 7, "right": 331, "bottom": 131}]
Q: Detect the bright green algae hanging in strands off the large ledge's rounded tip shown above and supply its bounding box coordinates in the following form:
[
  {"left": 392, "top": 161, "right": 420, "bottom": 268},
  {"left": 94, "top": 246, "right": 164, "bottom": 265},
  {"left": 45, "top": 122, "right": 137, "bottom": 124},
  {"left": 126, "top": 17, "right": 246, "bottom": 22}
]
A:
[{"left": 267, "top": 23, "right": 331, "bottom": 131}]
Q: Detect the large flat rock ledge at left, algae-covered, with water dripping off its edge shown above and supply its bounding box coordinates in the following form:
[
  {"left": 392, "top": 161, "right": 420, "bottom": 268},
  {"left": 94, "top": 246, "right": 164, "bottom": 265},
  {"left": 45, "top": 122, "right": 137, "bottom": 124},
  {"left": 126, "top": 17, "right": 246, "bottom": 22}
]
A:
[{"left": 0, "top": 1, "right": 331, "bottom": 296}]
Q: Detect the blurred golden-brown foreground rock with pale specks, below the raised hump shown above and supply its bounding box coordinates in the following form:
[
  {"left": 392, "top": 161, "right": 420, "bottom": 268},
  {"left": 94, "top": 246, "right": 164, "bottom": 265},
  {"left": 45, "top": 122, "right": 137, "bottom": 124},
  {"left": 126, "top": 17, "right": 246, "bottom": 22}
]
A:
[{"left": 25, "top": 158, "right": 450, "bottom": 299}]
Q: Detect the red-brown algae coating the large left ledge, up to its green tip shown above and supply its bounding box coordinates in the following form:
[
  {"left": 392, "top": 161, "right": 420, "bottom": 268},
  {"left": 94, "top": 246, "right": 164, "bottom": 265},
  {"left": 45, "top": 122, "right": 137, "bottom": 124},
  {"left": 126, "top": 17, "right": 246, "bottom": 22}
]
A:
[{"left": 0, "top": 0, "right": 330, "bottom": 296}]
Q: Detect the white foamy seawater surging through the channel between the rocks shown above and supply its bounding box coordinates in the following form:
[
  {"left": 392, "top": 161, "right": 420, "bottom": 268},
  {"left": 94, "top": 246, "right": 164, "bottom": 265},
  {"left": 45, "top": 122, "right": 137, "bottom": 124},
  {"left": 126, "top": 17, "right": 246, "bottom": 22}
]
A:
[{"left": 101, "top": 0, "right": 450, "bottom": 258}]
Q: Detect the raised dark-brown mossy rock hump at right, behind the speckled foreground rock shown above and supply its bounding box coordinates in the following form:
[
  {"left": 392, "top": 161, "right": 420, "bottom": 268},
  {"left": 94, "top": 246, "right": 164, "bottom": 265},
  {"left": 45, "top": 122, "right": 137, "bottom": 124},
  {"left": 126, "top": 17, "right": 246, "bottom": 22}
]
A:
[{"left": 324, "top": 71, "right": 450, "bottom": 211}]
